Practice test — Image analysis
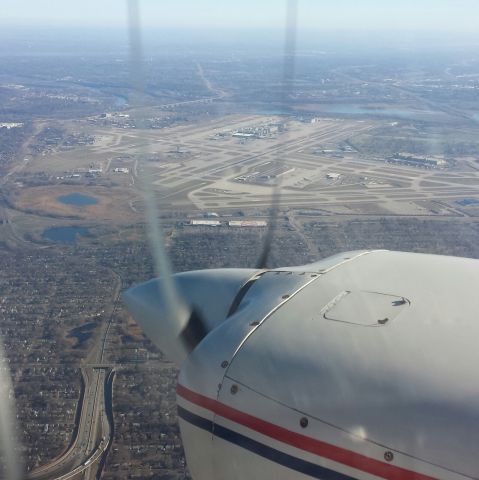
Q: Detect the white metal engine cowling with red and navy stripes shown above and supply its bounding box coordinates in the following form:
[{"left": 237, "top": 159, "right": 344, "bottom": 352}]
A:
[{"left": 127, "top": 251, "right": 479, "bottom": 480}]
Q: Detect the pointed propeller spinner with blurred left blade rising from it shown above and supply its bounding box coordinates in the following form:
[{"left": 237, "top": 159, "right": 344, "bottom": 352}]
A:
[{"left": 123, "top": 0, "right": 262, "bottom": 365}]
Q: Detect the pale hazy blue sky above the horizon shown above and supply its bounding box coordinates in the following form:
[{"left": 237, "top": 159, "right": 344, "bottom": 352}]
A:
[{"left": 0, "top": 0, "right": 479, "bottom": 32}]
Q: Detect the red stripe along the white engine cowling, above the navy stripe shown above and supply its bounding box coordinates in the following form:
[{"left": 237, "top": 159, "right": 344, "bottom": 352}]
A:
[{"left": 176, "top": 384, "right": 436, "bottom": 480}]
